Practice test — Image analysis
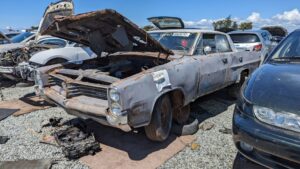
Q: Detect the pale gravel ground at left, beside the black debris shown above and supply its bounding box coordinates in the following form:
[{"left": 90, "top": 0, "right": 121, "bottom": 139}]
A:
[{"left": 0, "top": 87, "right": 88, "bottom": 169}]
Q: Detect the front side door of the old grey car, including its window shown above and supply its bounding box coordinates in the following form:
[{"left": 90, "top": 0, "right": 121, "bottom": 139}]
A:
[{"left": 196, "top": 33, "right": 231, "bottom": 96}]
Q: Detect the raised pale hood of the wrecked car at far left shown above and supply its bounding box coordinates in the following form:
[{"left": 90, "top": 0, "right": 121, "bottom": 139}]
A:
[{"left": 35, "top": 0, "right": 74, "bottom": 40}]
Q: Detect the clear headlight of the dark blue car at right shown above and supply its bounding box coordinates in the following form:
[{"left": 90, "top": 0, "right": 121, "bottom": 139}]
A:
[{"left": 253, "top": 106, "right": 300, "bottom": 132}]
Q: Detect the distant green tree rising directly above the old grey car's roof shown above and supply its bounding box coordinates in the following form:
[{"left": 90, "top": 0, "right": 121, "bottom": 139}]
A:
[{"left": 213, "top": 16, "right": 238, "bottom": 33}]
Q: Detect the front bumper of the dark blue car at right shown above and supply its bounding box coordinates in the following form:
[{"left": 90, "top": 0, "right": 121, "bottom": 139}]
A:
[{"left": 233, "top": 108, "right": 300, "bottom": 168}]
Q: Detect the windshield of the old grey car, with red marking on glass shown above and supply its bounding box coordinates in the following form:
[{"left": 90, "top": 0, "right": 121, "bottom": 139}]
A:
[{"left": 150, "top": 32, "right": 197, "bottom": 54}]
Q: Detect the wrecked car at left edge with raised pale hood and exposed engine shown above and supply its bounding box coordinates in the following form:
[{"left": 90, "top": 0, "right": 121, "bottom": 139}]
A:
[{"left": 0, "top": 0, "right": 74, "bottom": 80}]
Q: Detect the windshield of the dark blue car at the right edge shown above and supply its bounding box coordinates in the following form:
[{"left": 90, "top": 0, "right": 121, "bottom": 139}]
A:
[{"left": 270, "top": 31, "right": 300, "bottom": 60}]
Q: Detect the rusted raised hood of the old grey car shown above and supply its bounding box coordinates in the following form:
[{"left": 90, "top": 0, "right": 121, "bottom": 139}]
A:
[{"left": 42, "top": 9, "right": 173, "bottom": 55}]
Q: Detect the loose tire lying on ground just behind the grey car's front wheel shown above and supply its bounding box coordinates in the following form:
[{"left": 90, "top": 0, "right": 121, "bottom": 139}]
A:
[{"left": 172, "top": 116, "right": 199, "bottom": 136}]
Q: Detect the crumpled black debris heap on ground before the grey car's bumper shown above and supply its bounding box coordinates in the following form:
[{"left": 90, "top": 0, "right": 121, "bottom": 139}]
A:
[{"left": 54, "top": 119, "right": 101, "bottom": 159}]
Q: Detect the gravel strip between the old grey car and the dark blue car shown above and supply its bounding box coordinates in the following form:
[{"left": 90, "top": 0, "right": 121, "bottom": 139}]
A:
[{"left": 160, "top": 94, "right": 237, "bottom": 169}]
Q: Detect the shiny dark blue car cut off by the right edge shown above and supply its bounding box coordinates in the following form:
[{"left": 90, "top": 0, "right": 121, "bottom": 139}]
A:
[{"left": 233, "top": 30, "right": 300, "bottom": 168}]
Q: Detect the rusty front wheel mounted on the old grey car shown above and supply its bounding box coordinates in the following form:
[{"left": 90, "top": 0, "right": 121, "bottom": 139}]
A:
[{"left": 145, "top": 95, "right": 172, "bottom": 142}]
